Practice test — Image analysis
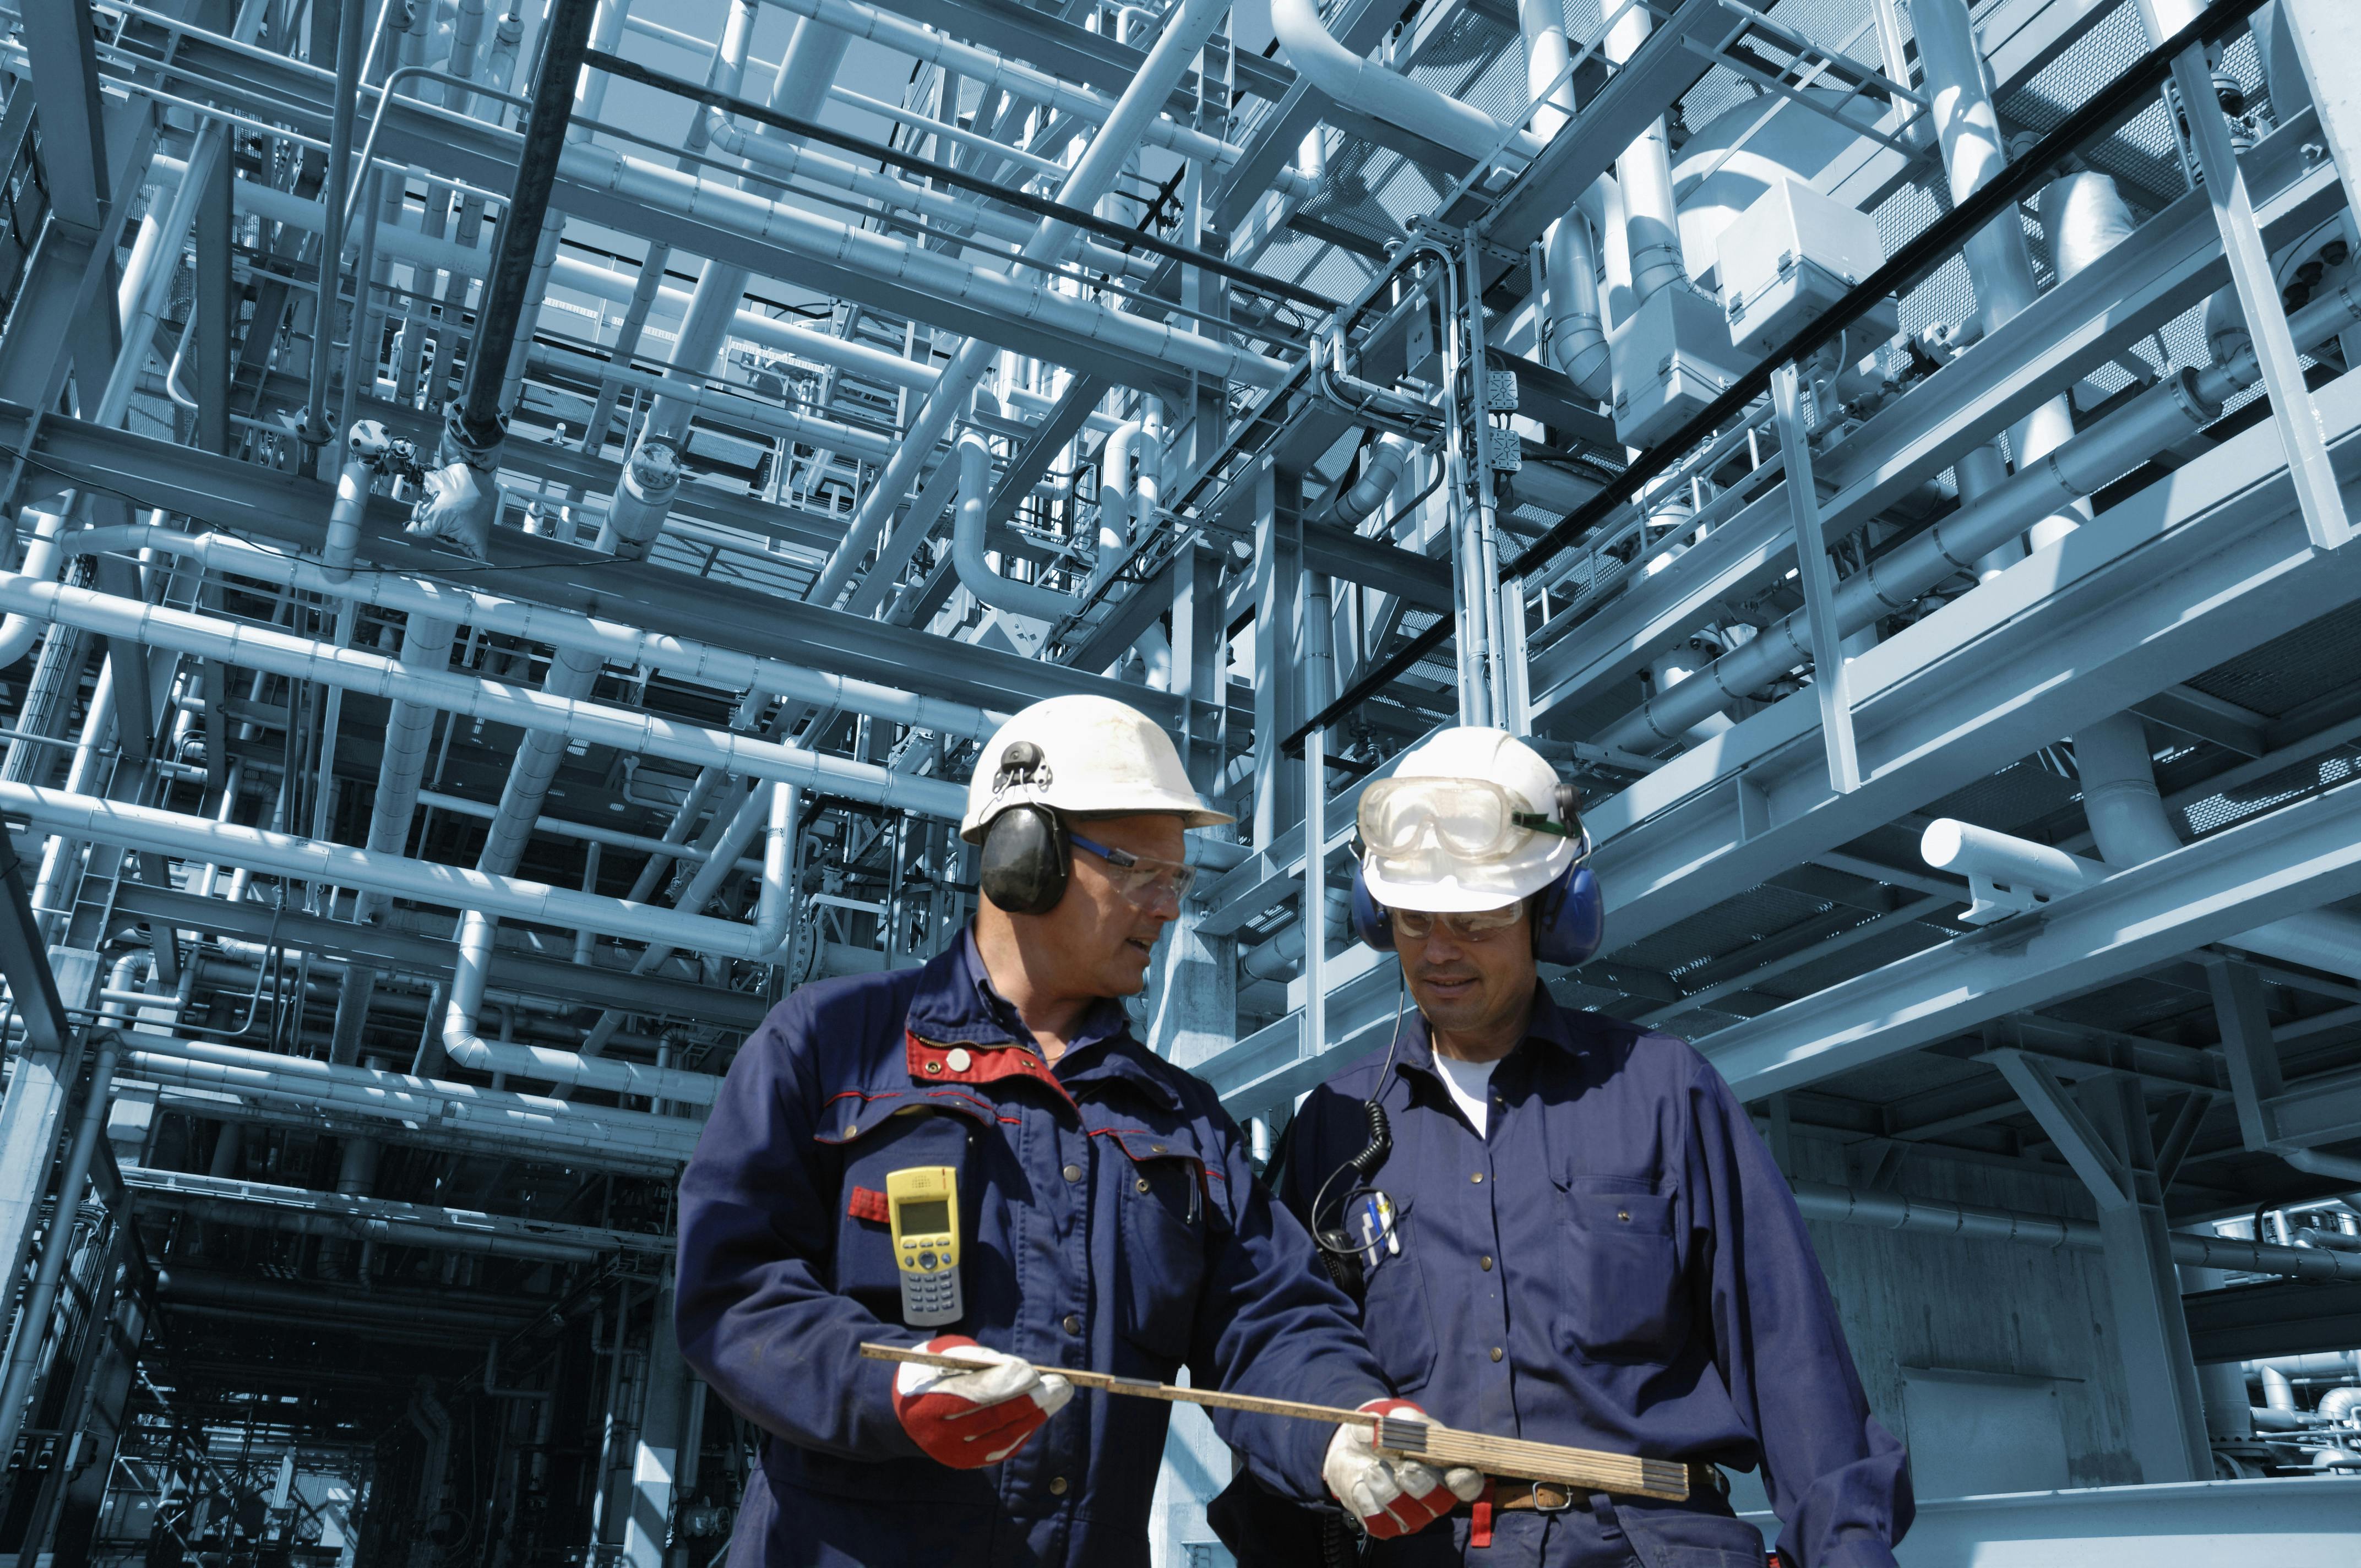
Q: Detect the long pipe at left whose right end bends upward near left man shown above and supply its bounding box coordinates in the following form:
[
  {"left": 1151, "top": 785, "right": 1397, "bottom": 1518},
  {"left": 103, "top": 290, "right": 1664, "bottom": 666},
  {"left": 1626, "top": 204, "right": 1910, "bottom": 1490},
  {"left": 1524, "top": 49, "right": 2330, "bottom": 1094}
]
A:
[{"left": 0, "top": 779, "right": 777, "bottom": 959}]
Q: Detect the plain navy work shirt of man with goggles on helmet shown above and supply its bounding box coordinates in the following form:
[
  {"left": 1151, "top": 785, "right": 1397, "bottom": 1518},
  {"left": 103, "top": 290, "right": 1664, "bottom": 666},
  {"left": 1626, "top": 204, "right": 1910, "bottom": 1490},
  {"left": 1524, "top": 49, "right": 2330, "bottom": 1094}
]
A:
[{"left": 1280, "top": 987, "right": 1912, "bottom": 1568}]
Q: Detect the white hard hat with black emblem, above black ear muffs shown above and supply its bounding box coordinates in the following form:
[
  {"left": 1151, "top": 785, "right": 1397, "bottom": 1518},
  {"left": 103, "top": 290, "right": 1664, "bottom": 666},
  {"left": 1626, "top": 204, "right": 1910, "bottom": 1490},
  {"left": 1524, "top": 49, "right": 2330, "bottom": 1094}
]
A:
[{"left": 959, "top": 696, "right": 1235, "bottom": 843}]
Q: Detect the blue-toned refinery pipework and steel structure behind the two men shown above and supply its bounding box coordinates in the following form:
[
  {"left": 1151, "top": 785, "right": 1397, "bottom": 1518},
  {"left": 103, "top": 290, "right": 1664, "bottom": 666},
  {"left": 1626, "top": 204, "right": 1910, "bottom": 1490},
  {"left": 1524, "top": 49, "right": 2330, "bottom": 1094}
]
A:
[{"left": 0, "top": 0, "right": 2361, "bottom": 1568}]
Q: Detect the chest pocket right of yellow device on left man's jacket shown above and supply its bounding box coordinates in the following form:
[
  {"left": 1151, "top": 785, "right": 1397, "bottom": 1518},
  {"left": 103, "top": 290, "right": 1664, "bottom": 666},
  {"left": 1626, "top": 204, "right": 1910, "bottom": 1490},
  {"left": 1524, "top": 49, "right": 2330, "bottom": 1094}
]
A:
[{"left": 1109, "top": 1131, "right": 1216, "bottom": 1365}]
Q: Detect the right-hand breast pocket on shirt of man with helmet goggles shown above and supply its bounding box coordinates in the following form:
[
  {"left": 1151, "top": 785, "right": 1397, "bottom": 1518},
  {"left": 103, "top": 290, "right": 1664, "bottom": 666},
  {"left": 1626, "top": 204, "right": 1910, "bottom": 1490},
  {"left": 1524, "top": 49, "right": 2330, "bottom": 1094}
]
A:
[{"left": 1558, "top": 1176, "right": 1688, "bottom": 1360}]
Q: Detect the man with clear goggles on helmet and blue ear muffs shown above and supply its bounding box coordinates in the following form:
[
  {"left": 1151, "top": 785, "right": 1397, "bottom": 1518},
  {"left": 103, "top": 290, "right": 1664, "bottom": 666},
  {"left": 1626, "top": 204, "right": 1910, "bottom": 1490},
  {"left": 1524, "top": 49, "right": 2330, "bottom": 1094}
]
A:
[{"left": 1216, "top": 727, "right": 1912, "bottom": 1568}]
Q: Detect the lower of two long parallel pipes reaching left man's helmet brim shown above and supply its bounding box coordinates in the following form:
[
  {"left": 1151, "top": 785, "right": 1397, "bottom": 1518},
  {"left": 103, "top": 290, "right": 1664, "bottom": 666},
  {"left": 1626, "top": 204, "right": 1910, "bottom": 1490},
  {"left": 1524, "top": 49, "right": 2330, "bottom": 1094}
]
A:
[{"left": 0, "top": 574, "right": 968, "bottom": 821}]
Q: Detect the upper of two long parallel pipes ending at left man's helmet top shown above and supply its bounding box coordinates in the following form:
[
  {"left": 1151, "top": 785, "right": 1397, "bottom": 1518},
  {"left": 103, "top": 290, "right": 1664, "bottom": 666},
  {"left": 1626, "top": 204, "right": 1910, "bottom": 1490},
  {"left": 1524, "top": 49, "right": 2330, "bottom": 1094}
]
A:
[{"left": 74, "top": 522, "right": 1008, "bottom": 739}]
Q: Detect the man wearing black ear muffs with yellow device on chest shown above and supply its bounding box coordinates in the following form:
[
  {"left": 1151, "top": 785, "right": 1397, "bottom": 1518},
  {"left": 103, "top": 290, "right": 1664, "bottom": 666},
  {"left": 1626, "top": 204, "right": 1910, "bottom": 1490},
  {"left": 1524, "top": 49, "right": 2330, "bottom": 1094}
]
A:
[{"left": 678, "top": 696, "right": 1481, "bottom": 1568}]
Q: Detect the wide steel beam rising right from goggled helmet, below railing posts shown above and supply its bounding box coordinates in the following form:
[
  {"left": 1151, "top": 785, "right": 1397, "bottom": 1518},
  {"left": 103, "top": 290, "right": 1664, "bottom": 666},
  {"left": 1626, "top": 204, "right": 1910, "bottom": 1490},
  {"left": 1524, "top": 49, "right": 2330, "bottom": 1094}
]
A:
[{"left": 1584, "top": 335, "right": 2361, "bottom": 968}]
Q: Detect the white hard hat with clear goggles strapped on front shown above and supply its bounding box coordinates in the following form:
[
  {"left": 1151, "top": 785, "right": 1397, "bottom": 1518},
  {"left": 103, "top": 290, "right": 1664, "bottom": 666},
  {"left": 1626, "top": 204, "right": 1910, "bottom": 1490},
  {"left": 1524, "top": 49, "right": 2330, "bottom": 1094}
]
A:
[{"left": 1362, "top": 725, "right": 1587, "bottom": 914}]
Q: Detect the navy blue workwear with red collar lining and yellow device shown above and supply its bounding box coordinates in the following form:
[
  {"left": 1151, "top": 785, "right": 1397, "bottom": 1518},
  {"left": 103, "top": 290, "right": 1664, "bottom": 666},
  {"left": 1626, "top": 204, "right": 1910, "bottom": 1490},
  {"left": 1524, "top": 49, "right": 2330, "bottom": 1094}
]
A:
[{"left": 678, "top": 933, "right": 1386, "bottom": 1568}]
